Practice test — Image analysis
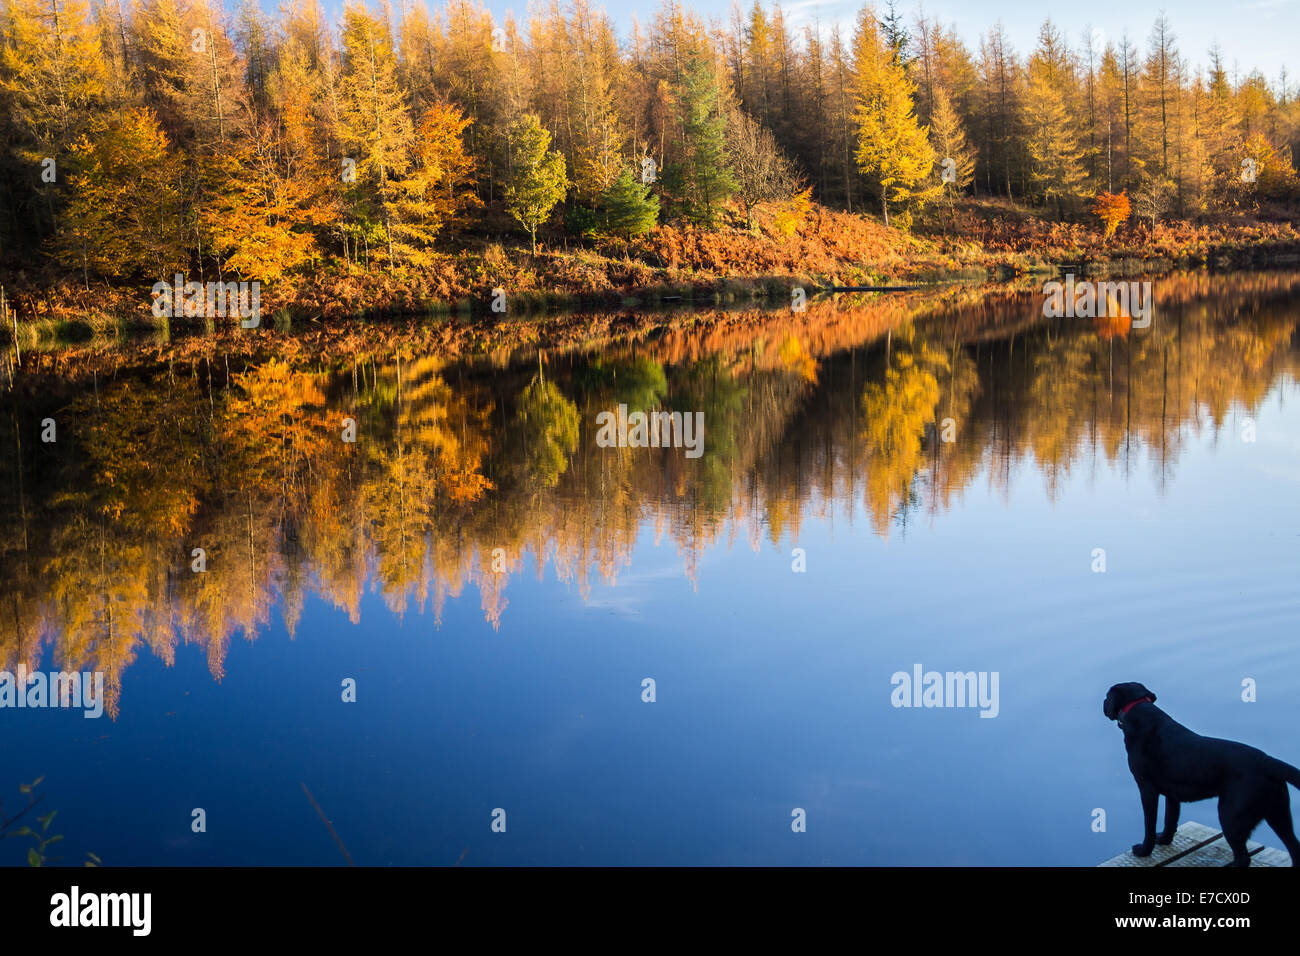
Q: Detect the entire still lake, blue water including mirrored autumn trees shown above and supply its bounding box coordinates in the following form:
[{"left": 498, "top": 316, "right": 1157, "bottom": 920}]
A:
[{"left": 0, "top": 272, "right": 1300, "bottom": 866}]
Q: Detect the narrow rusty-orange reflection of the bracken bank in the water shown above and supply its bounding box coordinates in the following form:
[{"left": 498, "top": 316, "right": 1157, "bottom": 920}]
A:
[{"left": 10, "top": 263, "right": 1300, "bottom": 388}]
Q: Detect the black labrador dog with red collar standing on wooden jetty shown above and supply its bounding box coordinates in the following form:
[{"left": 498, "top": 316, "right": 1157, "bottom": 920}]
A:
[{"left": 1101, "top": 683, "right": 1300, "bottom": 866}]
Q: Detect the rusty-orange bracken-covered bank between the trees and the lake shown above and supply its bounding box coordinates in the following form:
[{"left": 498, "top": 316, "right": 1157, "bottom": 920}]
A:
[{"left": 0, "top": 200, "right": 1300, "bottom": 350}]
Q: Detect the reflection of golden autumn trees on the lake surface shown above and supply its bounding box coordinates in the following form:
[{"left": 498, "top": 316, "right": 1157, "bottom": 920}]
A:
[{"left": 0, "top": 265, "right": 1300, "bottom": 715}]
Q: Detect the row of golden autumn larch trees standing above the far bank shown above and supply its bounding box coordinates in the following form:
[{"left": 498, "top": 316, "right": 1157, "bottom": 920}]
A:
[{"left": 0, "top": 0, "right": 1300, "bottom": 285}]
